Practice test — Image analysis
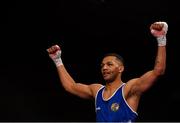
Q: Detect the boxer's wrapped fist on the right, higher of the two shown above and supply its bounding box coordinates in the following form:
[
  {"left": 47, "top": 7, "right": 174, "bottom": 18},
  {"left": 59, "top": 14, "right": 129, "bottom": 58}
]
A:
[{"left": 150, "top": 22, "right": 168, "bottom": 46}]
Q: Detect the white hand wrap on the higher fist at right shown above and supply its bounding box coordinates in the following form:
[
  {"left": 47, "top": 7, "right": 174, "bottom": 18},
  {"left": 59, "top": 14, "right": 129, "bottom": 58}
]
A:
[{"left": 156, "top": 22, "right": 168, "bottom": 46}]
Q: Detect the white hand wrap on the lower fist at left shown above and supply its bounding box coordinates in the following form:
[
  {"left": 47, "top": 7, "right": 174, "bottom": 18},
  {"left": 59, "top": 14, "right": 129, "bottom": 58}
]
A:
[{"left": 52, "top": 50, "right": 63, "bottom": 67}]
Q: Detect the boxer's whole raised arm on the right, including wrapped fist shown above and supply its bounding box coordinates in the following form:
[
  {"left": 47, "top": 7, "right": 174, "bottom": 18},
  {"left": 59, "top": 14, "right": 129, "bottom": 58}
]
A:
[{"left": 126, "top": 22, "right": 168, "bottom": 95}]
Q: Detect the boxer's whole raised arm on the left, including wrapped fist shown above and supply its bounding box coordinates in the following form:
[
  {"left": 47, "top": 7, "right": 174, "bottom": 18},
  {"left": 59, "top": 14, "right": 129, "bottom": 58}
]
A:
[{"left": 47, "top": 45, "right": 101, "bottom": 99}]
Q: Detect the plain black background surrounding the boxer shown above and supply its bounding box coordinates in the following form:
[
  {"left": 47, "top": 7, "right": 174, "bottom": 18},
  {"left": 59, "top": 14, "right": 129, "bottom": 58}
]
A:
[{"left": 0, "top": 0, "right": 180, "bottom": 121}]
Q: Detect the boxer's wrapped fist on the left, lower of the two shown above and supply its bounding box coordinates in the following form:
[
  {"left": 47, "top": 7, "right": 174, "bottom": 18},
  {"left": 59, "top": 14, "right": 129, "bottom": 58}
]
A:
[{"left": 47, "top": 45, "right": 63, "bottom": 67}]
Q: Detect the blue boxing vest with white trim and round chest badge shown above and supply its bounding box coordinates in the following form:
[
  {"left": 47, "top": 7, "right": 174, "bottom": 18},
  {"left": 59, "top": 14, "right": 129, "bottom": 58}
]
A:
[{"left": 95, "top": 83, "right": 137, "bottom": 122}]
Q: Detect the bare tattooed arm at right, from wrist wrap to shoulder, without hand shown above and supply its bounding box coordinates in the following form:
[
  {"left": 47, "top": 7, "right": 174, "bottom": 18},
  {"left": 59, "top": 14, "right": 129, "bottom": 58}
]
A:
[{"left": 131, "top": 46, "right": 166, "bottom": 94}]
